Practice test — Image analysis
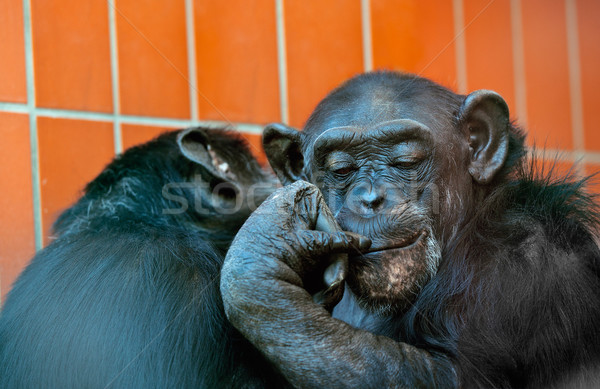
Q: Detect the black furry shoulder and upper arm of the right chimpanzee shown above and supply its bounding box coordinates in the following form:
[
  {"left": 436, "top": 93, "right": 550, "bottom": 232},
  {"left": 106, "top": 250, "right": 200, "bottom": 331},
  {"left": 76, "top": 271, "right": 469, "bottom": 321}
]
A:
[{"left": 394, "top": 157, "right": 600, "bottom": 388}]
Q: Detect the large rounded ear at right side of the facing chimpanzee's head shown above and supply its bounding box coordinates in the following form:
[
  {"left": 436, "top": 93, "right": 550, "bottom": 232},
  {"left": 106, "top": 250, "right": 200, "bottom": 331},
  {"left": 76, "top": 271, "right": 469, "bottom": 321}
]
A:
[{"left": 459, "top": 90, "right": 510, "bottom": 184}]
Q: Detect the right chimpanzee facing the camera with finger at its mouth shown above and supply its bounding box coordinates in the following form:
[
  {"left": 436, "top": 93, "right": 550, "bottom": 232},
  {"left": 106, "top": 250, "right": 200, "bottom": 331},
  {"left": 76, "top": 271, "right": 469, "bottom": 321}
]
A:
[{"left": 221, "top": 71, "right": 600, "bottom": 388}]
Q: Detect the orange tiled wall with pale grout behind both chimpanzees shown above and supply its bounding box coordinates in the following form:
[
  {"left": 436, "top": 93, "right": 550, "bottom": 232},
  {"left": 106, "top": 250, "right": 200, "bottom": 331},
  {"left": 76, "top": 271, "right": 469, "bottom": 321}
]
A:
[{"left": 0, "top": 0, "right": 600, "bottom": 296}]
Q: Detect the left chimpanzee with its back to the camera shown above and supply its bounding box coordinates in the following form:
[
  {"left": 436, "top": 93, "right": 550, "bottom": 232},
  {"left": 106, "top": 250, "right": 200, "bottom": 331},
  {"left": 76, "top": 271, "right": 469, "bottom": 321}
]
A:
[{"left": 0, "top": 128, "right": 277, "bottom": 389}]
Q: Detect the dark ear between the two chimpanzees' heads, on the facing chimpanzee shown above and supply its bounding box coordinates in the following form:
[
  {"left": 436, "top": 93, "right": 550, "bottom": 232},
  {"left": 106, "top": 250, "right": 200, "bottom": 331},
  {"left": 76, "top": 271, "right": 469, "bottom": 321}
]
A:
[{"left": 263, "top": 123, "right": 304, "bottom": 185}]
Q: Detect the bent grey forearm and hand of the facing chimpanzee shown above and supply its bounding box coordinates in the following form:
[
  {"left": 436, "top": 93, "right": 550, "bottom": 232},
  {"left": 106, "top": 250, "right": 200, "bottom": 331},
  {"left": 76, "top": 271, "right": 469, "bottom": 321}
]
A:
[{"left": 221, "top": 182, "right": 455, "bottom": 388}]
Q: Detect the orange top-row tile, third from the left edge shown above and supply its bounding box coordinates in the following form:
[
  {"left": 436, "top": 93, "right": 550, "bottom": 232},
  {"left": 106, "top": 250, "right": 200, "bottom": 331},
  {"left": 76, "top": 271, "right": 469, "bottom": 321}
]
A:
[{"left": 116, "top": 0, "right": 190, "bottom": 118}]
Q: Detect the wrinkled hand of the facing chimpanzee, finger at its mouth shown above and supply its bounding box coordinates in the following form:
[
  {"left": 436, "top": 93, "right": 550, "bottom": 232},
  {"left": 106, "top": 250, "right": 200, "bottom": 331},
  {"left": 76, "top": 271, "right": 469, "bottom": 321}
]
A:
[{"left": 220, "top": 181, "right": 371, "bottom": 308}]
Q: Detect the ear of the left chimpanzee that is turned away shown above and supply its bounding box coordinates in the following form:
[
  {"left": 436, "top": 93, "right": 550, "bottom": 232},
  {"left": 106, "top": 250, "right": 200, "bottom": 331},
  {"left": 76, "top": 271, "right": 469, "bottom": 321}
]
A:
[{"left": 177, "top": 128, "right": 237, "bottom": 184}]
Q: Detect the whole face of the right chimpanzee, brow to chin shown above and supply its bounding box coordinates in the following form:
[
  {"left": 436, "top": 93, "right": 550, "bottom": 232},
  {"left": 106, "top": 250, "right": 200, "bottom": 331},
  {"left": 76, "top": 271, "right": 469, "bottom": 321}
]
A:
[{"left": 307, "top": 102, "right": 452, "bottom": 310}]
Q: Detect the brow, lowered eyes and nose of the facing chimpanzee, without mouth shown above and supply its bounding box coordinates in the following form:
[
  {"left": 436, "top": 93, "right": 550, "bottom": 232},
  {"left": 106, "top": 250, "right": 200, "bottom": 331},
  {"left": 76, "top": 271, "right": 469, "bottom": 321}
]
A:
[{"left": 310, "top": 119, "right": 434, "bottom": 219}]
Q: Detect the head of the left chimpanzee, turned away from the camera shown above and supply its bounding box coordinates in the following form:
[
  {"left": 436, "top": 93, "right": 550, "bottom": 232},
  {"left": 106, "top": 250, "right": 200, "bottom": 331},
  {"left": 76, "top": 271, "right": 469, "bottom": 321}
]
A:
[{"left": 53, "top": 127, "right": 276, "bottom": 250}]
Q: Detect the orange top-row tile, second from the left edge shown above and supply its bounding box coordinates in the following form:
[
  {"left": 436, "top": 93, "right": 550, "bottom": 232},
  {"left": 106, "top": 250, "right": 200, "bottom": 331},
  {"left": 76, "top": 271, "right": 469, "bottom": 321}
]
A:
[{"left": 31, "top": 0, "right": 112, "bottom": 112}]
